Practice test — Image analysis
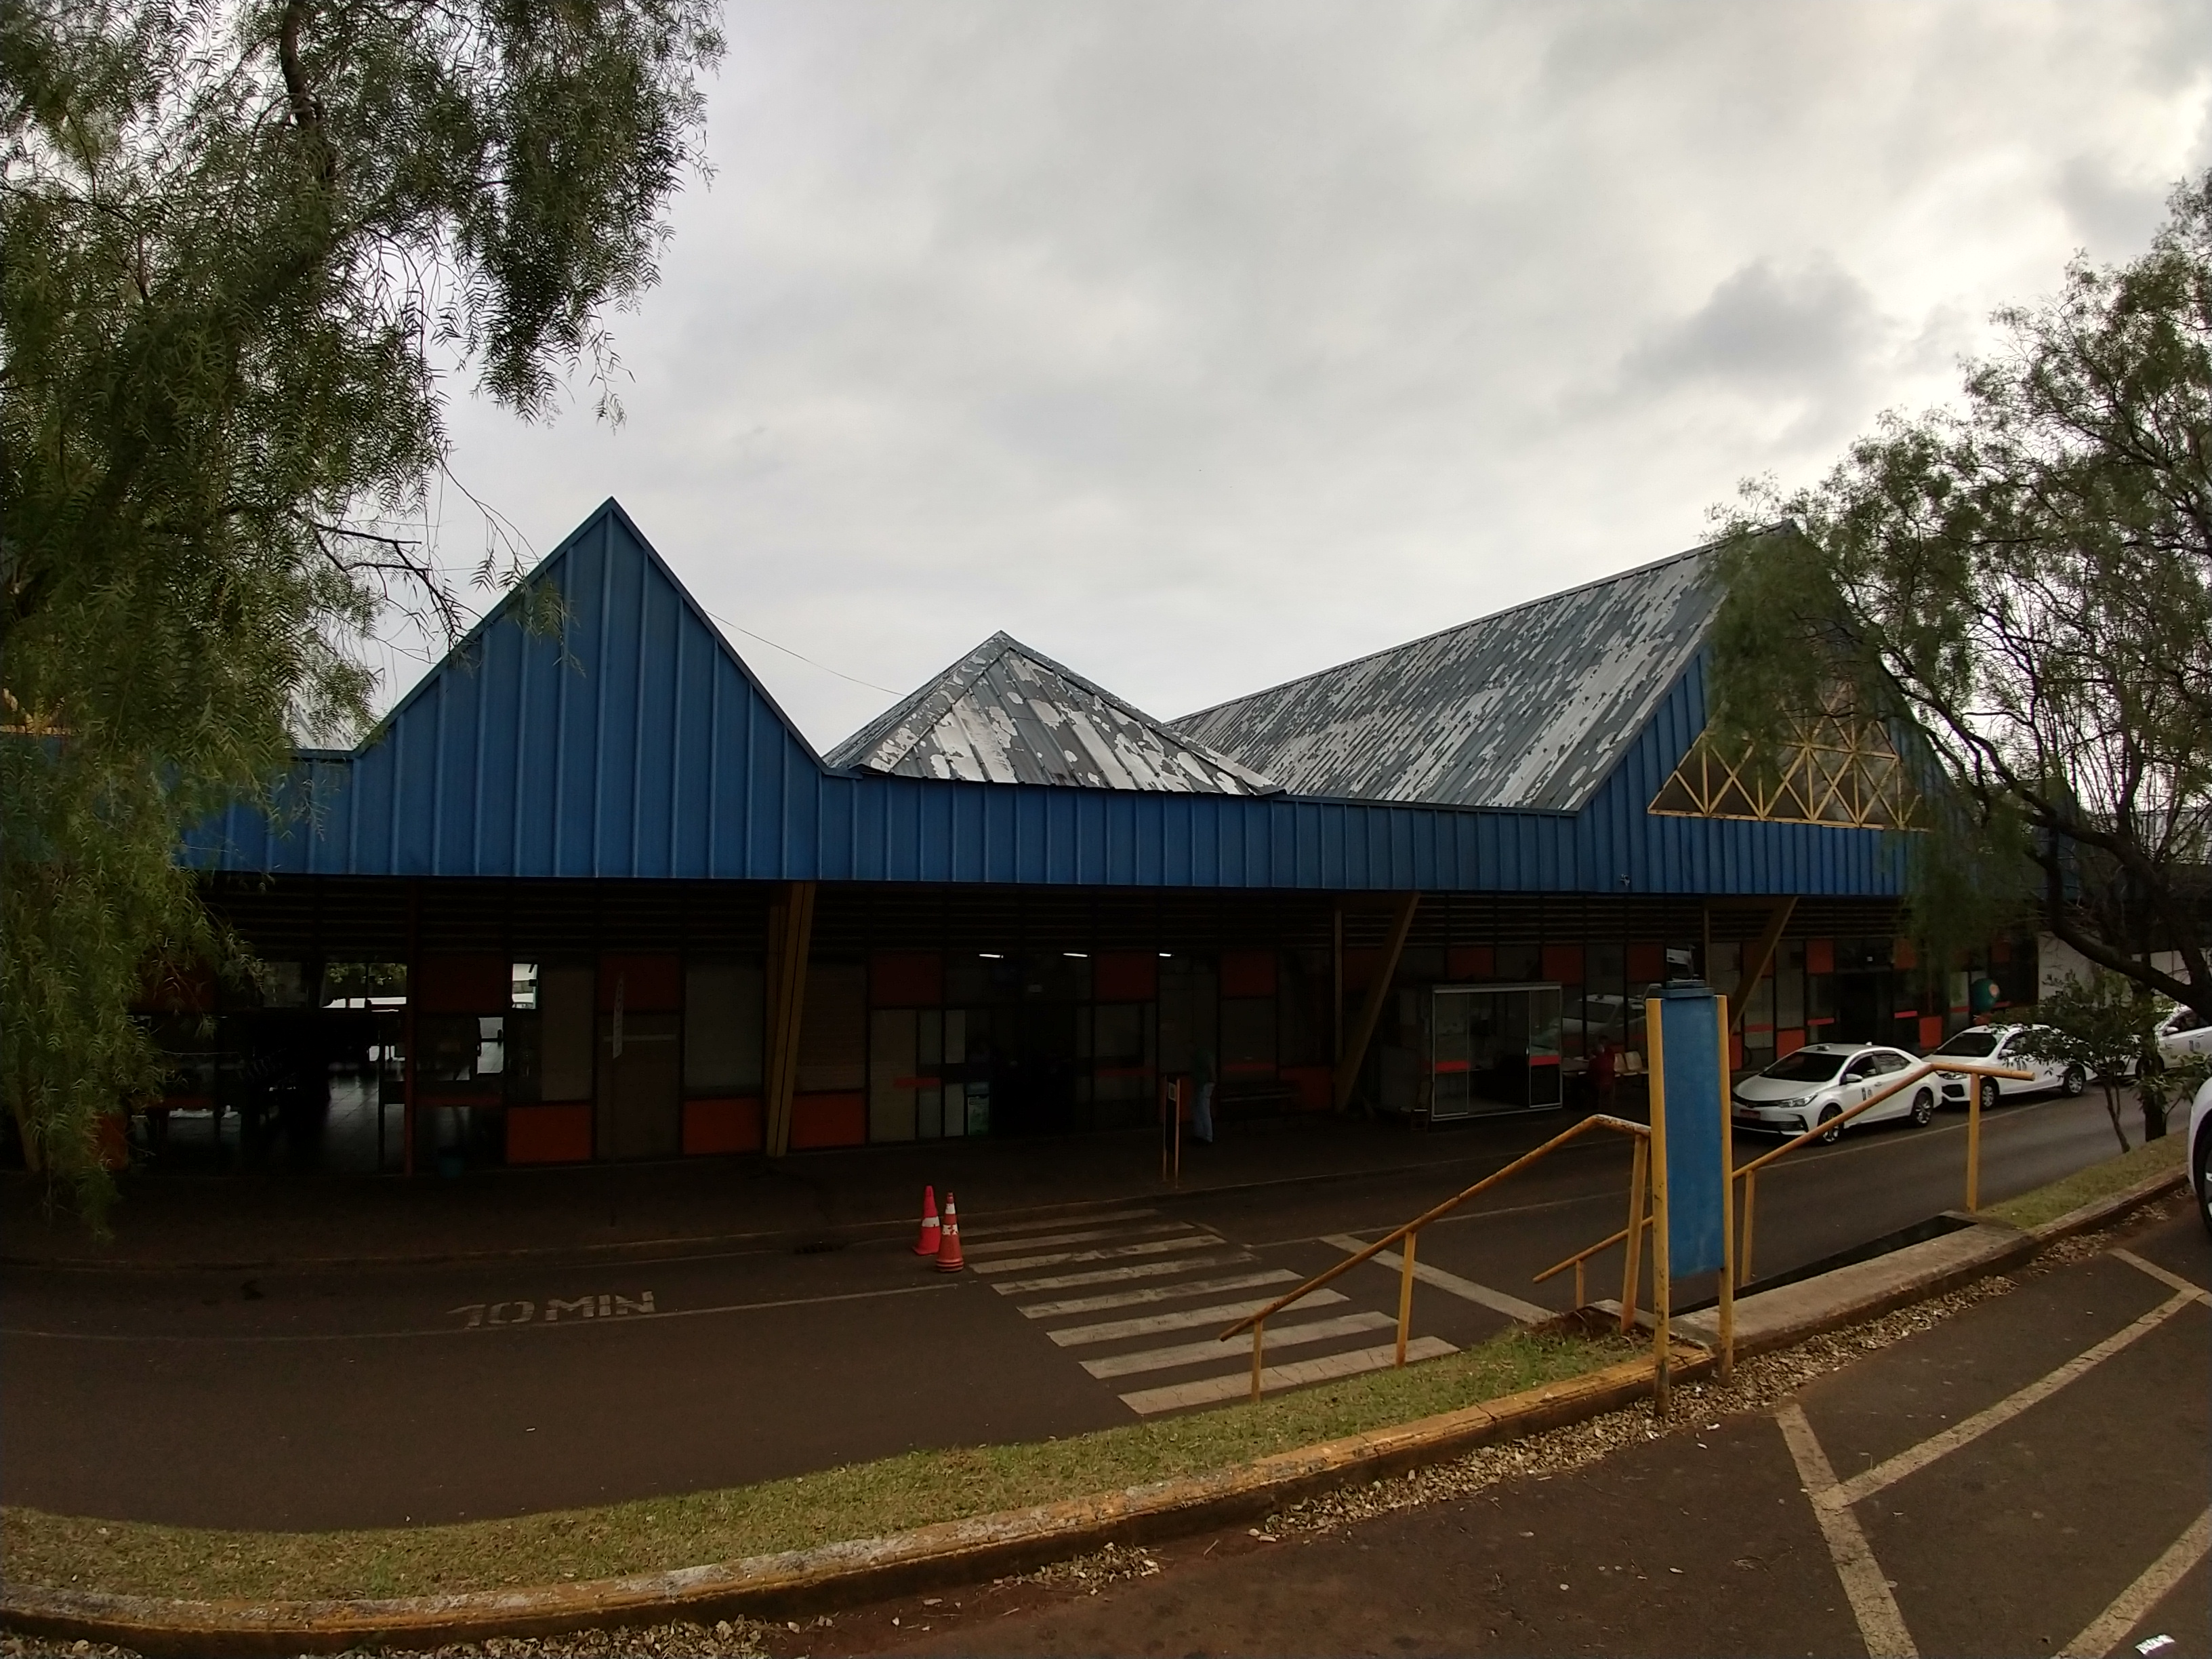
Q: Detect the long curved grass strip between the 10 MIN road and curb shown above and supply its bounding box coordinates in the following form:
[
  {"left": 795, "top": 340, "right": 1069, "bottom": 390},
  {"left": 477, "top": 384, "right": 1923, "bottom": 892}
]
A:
[{"left": 0, "top": 1332, "right": 1641, "bottom": 1599}]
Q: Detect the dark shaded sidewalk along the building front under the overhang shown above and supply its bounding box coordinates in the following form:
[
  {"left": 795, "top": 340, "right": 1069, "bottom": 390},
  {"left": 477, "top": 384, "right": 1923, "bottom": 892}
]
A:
[{"left": 0, "top": 1113, "right": 1628, "bottom": 1270}]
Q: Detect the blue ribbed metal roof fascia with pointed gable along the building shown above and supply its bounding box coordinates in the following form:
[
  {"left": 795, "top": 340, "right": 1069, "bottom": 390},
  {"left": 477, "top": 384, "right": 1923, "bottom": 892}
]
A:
[{"left": 186, "top": 502, "right": 1900, "bottom": 896}]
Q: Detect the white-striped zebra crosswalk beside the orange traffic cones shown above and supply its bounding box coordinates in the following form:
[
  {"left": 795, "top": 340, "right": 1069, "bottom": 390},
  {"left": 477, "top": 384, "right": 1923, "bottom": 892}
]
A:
[{"left": 962, "top": 1210, "right": 1456, "bottom": 1416}]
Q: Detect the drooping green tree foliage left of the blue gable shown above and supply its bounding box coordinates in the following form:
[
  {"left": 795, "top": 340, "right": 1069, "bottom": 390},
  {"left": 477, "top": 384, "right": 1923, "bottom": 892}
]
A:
[{"left": 0, "top": 0, "right": 721, "bottom": 1208}]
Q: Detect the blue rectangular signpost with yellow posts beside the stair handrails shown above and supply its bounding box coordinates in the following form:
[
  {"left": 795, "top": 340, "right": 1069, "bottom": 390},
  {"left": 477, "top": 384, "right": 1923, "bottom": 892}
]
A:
[{"left": 1643, "top": 984, "right": 1736, "bottom": 1414}]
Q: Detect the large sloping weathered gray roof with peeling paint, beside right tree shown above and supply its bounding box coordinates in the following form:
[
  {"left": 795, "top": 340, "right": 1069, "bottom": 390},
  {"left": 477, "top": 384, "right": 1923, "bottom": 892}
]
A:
[{"left": 1170, "top": 548, "right": 1719, "bottom": 812}]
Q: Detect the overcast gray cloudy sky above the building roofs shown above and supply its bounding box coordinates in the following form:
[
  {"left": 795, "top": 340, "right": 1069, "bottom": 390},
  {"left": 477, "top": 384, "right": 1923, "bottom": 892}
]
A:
[{"left": 407, "top": 0, "right": 2212, "bottom": 747}]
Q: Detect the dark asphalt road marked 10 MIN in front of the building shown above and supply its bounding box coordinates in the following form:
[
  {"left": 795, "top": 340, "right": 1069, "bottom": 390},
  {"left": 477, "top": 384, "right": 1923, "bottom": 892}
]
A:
[{"left": 0, "top": 1099, "right": 2150, "bottom": 1531}]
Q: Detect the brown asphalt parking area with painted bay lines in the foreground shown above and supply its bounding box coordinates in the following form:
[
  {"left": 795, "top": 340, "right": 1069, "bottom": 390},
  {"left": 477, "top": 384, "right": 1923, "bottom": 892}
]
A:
[{"left": 832, "top": 1214, "right": 2212, "bottom": 1659}]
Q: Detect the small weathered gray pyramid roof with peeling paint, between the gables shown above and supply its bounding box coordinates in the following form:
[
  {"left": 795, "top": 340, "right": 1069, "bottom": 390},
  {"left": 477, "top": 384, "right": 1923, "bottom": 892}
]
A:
[{"left": 827, "top": 633, "right": 1281, "bottom": 794}]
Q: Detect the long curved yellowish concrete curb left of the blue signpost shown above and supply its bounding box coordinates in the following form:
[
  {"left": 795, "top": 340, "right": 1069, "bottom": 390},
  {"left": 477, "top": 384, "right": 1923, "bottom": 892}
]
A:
[{"left": 0, "top": 1347, "right": 1712, "bottom": 1654}]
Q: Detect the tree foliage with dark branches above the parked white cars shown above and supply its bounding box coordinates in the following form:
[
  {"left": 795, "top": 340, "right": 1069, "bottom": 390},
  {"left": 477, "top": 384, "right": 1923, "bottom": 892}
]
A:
[{"left": 1715, "top": 175, "right": 2212, "bottom": 1015}]
